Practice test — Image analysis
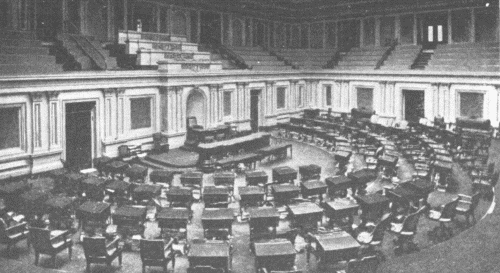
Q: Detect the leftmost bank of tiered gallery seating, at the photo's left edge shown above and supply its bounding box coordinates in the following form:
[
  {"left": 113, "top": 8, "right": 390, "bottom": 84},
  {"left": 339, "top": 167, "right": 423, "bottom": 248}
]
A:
[{"left": 0, "top": 30, "right": 63, "bottom": 75}]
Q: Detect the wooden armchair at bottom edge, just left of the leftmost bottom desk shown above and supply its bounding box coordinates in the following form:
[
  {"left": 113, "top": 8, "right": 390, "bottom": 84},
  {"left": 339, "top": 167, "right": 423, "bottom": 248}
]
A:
[{"left": 140, "top": 238, "right": 175, "bottom": 273}]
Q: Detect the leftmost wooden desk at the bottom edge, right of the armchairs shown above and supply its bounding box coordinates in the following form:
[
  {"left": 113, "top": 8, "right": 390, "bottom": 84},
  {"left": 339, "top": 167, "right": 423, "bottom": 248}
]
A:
[{"left": 188, "top": 242, "right": 231, "bottom": 272}]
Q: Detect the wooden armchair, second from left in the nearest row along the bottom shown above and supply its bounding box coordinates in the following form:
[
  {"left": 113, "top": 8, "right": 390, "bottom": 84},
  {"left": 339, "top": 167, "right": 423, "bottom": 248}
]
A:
[{"left": 29, "top": 227, "right": 73, "bottom": 267}]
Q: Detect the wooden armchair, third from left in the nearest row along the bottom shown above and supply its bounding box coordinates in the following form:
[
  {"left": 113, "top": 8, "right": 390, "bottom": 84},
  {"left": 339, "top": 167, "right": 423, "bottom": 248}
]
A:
[{"left": 83, "top": 237, "right": 123, "bottom": 272}]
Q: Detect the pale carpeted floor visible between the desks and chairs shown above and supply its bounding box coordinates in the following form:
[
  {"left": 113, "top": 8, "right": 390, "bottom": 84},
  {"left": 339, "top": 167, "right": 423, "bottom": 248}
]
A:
[{"left": 0, "top": 136, "right": 494, "bottom": 273}]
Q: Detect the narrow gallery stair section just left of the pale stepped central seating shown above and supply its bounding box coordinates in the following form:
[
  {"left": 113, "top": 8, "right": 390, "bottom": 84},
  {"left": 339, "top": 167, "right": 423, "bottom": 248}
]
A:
[{"left": 58, "top": 34, "right": 118, "bottom": 70}]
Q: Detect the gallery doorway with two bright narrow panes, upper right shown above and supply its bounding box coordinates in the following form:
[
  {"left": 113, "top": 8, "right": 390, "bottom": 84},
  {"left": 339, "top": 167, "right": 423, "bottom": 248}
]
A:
[{"left": 421, "top": 13, "right": 448, "bottom": 49}]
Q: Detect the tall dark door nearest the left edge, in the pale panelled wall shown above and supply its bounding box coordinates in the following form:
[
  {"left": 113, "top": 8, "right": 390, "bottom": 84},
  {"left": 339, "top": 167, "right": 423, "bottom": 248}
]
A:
[{"left": 66, "top": 102, "right": 95, "bottom": 170}]
